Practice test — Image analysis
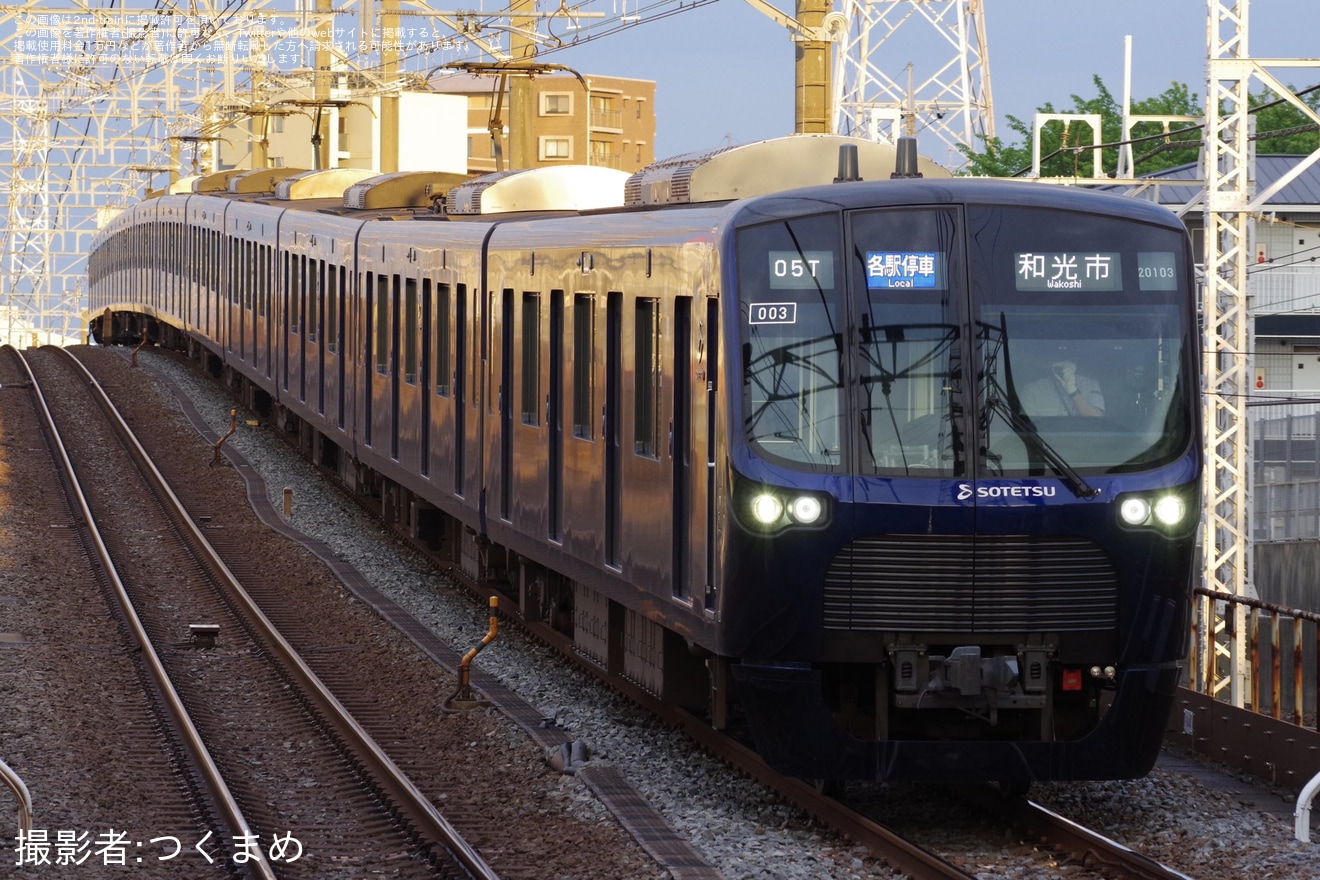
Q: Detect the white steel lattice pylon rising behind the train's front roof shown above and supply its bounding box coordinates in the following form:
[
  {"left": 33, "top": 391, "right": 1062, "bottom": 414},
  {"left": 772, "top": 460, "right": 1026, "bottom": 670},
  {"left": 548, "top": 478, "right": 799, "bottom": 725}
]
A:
[{"left": 834, "top": 0, "right": 994, "bottom": 168}]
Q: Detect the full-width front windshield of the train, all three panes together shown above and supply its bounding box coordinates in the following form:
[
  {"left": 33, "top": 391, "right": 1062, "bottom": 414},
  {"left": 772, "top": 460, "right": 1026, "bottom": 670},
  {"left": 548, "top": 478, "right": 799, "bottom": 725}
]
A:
[{"left": 738, "top": 204, "right": 1195, "bottom": 478}]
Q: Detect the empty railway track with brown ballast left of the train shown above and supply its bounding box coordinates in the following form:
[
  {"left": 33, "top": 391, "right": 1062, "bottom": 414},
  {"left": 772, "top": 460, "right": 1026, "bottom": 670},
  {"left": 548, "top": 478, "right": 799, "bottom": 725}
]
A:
[{"left": 26, "top": 350, "right": 498, "bottom": 877}]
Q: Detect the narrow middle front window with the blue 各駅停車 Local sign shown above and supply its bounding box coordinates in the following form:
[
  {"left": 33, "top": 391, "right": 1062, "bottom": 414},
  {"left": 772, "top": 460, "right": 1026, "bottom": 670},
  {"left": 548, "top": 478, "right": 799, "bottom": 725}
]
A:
[{"left": 849, "top": 208, "right": 965, "bottom": 476}]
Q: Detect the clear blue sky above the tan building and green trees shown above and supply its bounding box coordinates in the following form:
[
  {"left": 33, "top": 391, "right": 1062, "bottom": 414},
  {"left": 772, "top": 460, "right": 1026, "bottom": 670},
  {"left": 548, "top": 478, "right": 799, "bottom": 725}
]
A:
[{"left": 535, "top": 0, "right": 1320, "bottom": 157}]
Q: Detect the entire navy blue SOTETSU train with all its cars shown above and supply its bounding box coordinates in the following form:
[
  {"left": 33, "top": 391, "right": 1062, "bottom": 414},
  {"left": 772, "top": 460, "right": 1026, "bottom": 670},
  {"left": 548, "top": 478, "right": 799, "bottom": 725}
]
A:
[{"left": 88, "top": 136, "right": 1201, "bottom": 785}]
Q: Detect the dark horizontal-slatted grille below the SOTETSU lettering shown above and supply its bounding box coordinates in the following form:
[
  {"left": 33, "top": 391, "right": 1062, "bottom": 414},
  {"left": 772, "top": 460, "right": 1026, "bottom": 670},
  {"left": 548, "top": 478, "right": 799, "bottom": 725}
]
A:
[{"left": 825, "top": 534, "right": 1118, "bottom": 633}]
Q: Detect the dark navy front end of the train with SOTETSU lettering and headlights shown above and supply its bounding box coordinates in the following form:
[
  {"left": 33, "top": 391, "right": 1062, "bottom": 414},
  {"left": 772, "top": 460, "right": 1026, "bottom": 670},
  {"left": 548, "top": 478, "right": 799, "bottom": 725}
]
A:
[{"left": 721, "top": 179, "right": 1201, "bottom": 785}]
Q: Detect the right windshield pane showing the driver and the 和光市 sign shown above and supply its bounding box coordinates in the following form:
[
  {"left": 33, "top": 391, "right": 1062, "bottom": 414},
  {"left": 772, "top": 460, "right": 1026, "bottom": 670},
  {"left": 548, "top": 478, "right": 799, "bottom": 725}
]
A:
[{"left": 968, "top": 207, "right": 1195, "bottom": 476}]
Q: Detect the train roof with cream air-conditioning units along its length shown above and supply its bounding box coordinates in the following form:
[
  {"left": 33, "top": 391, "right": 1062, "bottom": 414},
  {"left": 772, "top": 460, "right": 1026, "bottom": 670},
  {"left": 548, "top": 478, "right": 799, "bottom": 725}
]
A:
[{"left": 105, "top": 135, "right": 1176, "bottom": 238}]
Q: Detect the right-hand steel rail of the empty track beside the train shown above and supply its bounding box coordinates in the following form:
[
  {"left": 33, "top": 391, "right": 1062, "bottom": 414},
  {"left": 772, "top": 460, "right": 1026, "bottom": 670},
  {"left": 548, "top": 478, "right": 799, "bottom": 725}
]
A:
[{"left": 50, "top": 348, "right": 499, "bottom": 880}]
